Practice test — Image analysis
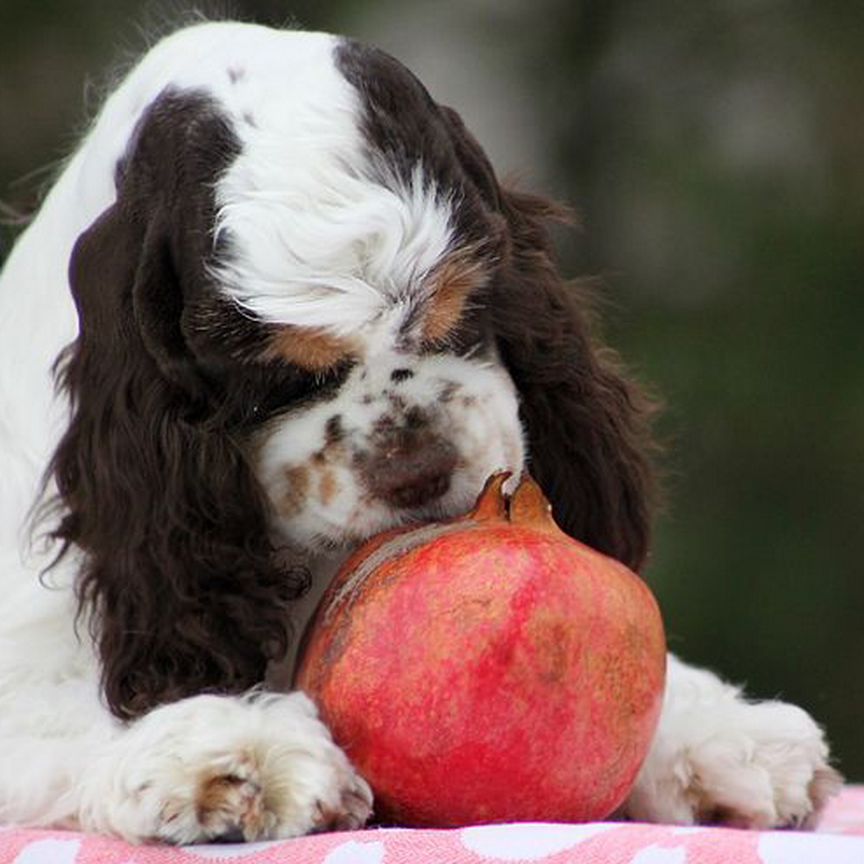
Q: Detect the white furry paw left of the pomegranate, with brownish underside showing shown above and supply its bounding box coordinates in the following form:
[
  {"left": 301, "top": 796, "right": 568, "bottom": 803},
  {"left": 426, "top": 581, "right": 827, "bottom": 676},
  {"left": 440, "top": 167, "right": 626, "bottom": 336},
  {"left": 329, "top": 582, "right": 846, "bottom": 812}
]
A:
[{"left": 81, "top": 693, "right": 372, "bottom": 844}]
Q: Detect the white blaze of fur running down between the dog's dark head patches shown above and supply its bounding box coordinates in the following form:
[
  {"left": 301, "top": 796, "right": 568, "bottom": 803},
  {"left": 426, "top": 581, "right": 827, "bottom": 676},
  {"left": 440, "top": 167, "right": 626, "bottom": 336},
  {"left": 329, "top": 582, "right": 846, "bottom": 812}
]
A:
[{"left": 188, "top": 23, "right": 453, "bottom": 335}]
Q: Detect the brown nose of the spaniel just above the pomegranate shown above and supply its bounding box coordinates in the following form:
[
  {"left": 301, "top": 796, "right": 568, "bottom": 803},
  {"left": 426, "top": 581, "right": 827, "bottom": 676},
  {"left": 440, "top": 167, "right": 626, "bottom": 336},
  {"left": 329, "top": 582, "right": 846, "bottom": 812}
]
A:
[{"left": 364, "top": 429, "right": 457, "bottom": 508}]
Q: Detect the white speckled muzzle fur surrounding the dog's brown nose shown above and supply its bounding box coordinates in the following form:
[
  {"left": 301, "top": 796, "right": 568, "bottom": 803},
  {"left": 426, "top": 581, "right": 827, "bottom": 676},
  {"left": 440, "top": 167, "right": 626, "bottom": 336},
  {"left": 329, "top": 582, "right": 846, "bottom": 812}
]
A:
[{"left": 258, "top": 352, "right": 524, "bottom": 550}]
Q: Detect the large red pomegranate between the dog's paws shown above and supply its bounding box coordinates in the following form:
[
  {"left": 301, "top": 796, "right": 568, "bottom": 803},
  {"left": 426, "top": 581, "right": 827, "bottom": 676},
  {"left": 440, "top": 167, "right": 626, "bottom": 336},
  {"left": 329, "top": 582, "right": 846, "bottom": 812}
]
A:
[{"left": 296, "top": 474, "right": 666, "bottom": 827}]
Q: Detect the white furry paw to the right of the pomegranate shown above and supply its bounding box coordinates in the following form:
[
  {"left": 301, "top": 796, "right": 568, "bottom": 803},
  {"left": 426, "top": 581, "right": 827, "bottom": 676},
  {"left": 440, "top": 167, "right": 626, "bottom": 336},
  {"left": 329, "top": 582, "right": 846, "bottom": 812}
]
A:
[{"left": 624, "top": 658, "right": 842, "bottom": 829}]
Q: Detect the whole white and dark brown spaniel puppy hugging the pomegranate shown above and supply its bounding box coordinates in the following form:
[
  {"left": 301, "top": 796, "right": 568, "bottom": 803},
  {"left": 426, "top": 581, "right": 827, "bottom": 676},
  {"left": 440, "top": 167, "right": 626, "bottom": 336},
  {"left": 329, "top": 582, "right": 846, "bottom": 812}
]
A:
[{"left": 0, "top": 23, "right": 838, "bottom": 843}]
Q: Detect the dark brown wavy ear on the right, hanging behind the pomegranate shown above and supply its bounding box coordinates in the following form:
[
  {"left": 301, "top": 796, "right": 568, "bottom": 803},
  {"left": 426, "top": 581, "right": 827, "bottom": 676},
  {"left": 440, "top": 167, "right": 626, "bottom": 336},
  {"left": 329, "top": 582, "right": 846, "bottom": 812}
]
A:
[{"left": 493, "top": 191, "right": 653, "bottom": 571}]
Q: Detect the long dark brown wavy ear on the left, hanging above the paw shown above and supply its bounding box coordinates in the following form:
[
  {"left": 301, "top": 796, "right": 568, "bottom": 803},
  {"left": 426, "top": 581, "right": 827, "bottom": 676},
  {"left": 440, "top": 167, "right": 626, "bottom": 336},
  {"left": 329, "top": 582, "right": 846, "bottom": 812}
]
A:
[{"left": 50, "top": 91, "right": 303, "bottom": 717}]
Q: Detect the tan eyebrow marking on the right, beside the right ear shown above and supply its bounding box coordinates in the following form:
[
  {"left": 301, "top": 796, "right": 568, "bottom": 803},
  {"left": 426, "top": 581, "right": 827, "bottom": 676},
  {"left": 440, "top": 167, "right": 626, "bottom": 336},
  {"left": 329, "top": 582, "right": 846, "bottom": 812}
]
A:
[{"left": 421, "top": 249, "right": 489, "bottom": 345}]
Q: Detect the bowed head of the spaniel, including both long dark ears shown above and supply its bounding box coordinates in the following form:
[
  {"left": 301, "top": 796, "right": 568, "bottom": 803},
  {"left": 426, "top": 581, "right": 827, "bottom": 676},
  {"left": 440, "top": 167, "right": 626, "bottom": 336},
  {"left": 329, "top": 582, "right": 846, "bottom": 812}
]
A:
[{"left": 53, "top": 25, "right": 649, "bottom": 713}]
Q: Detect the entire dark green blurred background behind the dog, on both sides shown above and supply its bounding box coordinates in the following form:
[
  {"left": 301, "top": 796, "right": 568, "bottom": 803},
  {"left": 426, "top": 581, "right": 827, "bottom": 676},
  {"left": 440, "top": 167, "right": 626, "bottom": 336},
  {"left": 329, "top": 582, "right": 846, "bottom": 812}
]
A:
[{"left": 0, "top": 0, "right": 864, "bottom": 780}]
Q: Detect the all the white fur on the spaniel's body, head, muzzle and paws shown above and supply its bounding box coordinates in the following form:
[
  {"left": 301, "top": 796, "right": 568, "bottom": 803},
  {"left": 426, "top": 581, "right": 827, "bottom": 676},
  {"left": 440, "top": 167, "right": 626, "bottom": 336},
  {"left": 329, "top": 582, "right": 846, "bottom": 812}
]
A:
[{"left": 0, "top": 18, "right": 833, "bottom": 842}]
